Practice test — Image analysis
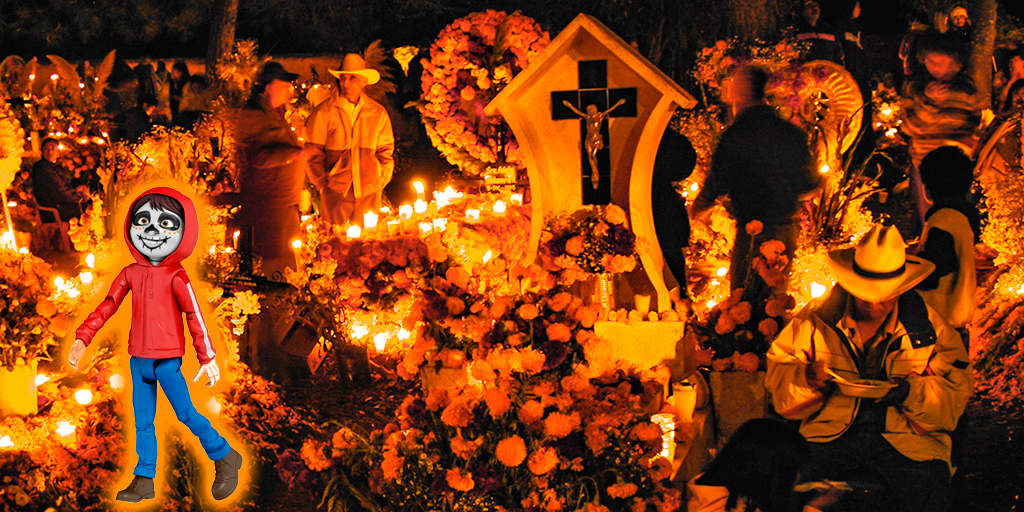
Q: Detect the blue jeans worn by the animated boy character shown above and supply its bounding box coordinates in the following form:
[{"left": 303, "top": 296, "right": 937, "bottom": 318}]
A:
[{"left": 131, "top": 355, "right": 231, "bottom": 478}]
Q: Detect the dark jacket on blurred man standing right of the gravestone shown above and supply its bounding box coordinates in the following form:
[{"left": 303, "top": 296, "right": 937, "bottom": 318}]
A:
[{"left": 694, "top": 105, "right": 820, "bottom": 229}]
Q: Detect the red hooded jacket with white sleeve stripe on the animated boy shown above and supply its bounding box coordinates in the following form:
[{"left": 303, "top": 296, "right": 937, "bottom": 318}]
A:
[{"left": 75, "top": 186, "right": 216, "bottom": 365}]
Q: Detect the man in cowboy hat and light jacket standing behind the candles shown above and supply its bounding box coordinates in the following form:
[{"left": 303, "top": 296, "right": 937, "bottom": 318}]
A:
[{"left": 306, "top": 53, "right": 394, "bottom": 224}]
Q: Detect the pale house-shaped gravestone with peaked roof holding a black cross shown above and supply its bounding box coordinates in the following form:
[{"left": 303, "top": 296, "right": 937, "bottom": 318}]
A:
[{"left": 485, "top": 14, "right": 696, "bottom": 310}]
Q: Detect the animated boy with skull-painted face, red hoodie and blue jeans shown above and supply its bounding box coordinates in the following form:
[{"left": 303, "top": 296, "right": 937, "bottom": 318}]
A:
[{"left": 68, "top": 187, "right": 242, "bottom": 503}]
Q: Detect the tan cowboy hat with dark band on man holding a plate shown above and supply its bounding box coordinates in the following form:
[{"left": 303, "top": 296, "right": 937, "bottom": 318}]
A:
[{"left": 828, "top": 224, "right": 935, "bottom": 302}]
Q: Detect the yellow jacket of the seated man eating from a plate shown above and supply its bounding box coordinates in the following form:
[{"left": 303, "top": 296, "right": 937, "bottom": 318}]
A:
[{"left": 765, "top": 286, "right": 974, "bottom": 464}]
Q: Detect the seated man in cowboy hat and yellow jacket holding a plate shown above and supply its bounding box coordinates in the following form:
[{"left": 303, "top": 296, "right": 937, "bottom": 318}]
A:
[{"left": 765, "top": 224, "right": 973, "bottom": 512}]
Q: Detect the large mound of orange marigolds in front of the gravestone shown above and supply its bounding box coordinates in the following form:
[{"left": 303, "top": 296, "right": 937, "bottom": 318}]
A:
[{"left": 303, "top": 256, "right": 682, "bottom": 512}]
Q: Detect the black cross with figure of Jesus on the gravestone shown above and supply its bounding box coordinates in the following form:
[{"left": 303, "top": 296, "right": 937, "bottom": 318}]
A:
[{"left": 551, "top": 60, "right": 637, "bottom": 205}]
